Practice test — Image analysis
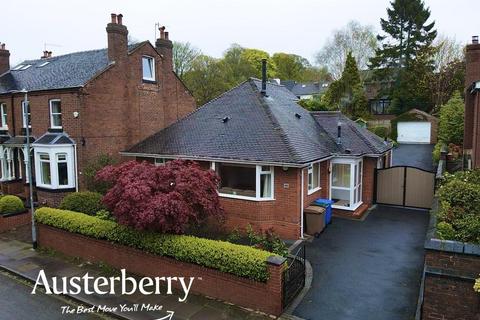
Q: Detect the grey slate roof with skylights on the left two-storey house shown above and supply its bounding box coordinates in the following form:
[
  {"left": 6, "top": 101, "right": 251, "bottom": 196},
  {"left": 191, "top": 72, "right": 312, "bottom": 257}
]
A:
[{"left": 0, "top": 42, "right": 144, "bottom": 94}]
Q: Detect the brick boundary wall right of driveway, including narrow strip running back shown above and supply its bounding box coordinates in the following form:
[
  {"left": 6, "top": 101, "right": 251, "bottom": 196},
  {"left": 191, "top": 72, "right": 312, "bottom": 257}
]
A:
[{"left": 416, "top": 199, "right": 480, "bottom": 320}]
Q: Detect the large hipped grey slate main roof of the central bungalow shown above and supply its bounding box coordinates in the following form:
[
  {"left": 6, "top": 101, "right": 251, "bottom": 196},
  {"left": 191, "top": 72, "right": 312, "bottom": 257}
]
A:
[{"left": 124, "top": 79, "right": 390, "bottom": 165}]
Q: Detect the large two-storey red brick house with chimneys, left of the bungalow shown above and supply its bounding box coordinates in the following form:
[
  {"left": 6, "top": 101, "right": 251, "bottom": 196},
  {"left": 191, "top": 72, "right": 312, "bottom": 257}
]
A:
[{"left": 0, "top": 14, "right": 195, "bottom": 205}]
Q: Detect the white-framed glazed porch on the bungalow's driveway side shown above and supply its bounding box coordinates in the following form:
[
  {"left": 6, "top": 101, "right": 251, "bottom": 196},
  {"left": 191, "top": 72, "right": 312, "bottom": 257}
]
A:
[{"left": 329, "top": 158, "right": 364, "bottom": 211}]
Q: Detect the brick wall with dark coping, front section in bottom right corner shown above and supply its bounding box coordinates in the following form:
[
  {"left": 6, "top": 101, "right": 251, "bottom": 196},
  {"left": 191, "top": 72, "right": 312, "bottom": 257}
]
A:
[{"left": 422, "top": 250, "right": 480, "bottom": 320}]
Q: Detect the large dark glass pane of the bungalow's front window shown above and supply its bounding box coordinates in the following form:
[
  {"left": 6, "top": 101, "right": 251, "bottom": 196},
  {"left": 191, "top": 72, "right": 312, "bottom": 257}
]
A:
[{"left": 215, "top": 162, "right": 256, "bottom": 197}]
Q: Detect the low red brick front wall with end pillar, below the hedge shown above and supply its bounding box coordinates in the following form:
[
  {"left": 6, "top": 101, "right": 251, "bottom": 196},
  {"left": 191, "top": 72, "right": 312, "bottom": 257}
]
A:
[{"left": 37, "top": 224, "right": 285, "bottom": 316}]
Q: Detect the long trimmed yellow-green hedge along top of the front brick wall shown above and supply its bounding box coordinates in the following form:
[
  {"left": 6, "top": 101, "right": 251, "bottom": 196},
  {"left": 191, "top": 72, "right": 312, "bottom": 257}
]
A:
[{"left": 35, "top": 207, "right": 273, "bottom": 282}]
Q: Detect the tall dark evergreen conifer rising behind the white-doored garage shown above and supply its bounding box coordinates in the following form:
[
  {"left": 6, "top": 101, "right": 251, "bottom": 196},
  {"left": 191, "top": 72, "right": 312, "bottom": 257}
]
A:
[{"left": 370, "top": 0, "right": 437, "bottom": 114}]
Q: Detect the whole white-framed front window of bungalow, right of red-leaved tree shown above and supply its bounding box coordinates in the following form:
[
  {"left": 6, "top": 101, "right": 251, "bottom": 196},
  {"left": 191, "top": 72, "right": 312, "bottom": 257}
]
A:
[{"left": 212, "top": 162, "right": 274, "bottom": 201}]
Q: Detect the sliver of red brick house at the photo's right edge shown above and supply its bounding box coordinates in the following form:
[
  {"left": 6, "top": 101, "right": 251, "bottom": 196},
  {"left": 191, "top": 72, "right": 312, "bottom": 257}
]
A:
[{"left": 463, "top": 36, "right": 480, "bottom": 168}]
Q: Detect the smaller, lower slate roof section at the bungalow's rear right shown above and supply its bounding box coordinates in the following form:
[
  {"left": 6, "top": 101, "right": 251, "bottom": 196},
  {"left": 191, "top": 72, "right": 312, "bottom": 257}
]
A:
[{"left": 311, "top": 111, "right": 392, "bottom": 155}]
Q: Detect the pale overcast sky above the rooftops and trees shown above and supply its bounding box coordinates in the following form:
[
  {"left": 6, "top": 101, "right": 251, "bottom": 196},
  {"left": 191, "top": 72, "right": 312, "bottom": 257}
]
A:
[{"left": 0, "top": 0, "right": 480, "bottom": 65}]
